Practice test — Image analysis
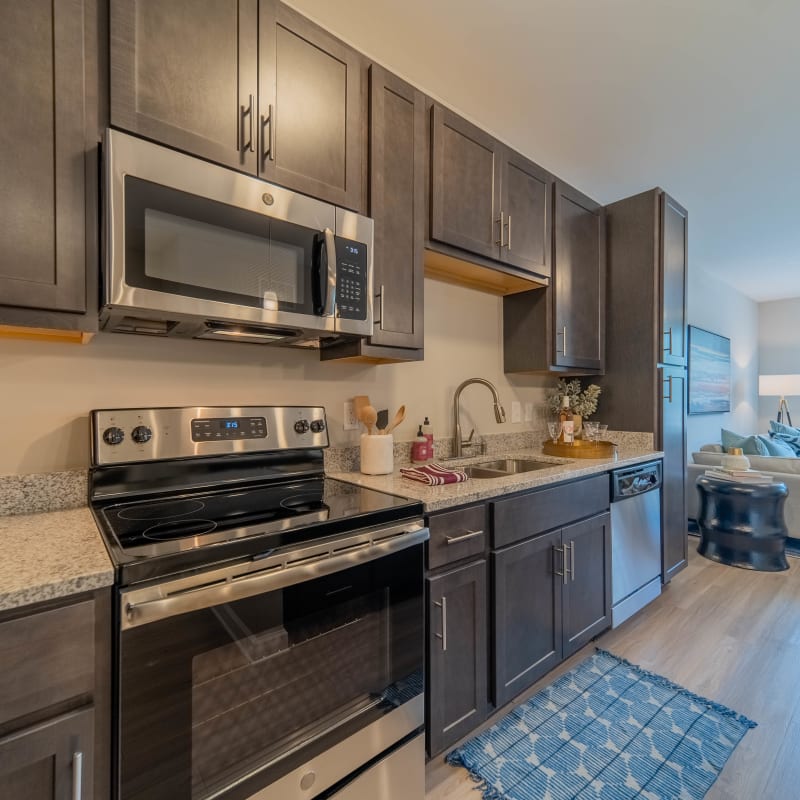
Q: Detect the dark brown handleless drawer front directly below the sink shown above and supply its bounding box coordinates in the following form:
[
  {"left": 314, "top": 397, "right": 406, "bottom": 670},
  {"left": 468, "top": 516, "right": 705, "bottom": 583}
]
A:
[{"left": 491, "top": 473, "right": 609, "bottom": 549}]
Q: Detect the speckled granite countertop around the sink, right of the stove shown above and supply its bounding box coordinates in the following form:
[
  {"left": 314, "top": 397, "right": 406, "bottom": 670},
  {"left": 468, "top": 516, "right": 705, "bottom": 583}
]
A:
[{"left": 328, "top": 447, "right": 664, "bottom": 511}]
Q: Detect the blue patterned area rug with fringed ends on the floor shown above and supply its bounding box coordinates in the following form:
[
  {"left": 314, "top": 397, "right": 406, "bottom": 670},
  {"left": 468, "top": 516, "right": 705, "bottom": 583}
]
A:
[{"left": 447, "top": 650, "right": 756, "bottom": 800}]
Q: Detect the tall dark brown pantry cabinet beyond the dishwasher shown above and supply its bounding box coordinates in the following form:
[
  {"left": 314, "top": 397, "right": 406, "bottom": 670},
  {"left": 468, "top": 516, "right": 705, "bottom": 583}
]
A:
[{"left": 596, "top": 189, "right": 688, "bottom": 583}]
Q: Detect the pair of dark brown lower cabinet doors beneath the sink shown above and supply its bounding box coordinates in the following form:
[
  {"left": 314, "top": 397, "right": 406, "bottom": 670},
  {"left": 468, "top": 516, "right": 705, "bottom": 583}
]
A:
[{"left": 492, "top": 513, "right": 611, "bottom": 707}]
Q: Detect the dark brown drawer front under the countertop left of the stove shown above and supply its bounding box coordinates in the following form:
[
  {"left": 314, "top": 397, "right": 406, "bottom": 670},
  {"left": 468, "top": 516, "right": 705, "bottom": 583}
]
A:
[{"left": 0, "top": 600, "right": 95, "bottom": 724}]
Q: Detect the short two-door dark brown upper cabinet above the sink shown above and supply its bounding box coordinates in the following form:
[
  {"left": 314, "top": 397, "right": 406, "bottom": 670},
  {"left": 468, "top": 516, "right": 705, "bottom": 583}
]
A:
[{"left": 430, "top": 105, "right": 553, "bottom": 278}]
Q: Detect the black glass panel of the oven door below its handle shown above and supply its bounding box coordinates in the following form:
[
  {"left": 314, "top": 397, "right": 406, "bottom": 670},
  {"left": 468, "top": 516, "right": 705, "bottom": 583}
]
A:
[{"left": 118, "top": 545, "right": 424, "bottom": 800}]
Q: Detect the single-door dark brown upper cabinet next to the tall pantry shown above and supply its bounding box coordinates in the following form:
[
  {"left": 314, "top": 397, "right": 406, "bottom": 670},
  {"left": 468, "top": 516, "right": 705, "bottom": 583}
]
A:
[{"left": 503, "top": 180, "right": 606, "bottom": 375}]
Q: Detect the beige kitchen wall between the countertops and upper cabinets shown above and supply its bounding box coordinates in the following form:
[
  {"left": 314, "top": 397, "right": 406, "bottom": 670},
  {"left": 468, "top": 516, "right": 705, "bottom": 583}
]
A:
[{"left": 0, "top": 281, "right": 553, "bottom": 474}]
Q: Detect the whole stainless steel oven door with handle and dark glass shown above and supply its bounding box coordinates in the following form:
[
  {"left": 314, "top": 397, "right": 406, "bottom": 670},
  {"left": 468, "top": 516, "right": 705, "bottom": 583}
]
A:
[{"left": 116, "top": 523, "right": 428, "bottom": 800}]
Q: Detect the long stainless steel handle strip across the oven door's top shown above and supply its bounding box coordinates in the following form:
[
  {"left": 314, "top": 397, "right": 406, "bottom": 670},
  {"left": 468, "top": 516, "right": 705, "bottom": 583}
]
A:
[{"left": 120, "top": 527, "right": 430, "bottom": 630}]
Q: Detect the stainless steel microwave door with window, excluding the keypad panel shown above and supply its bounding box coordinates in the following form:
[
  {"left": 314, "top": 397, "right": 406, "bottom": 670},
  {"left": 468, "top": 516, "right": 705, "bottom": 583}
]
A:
[{"left": 105, "top": 131, "right": 337, "bottom": 332}]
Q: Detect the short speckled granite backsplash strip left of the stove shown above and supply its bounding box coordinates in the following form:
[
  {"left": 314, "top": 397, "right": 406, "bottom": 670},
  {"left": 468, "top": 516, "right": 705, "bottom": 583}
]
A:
[{"left": 0, "top": 470, "right": 88, "bottom": 516}]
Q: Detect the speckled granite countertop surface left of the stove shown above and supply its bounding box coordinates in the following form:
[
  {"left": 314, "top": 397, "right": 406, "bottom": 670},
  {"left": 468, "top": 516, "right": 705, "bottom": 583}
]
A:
[{"left": 0, "top": 507, "right": 114, "bottom": 611}]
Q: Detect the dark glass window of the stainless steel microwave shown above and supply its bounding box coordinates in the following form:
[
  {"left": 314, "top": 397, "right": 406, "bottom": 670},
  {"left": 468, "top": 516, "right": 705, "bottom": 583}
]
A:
[{"left": 125, "top": 176, "right": 320, "bottom": 314}]
